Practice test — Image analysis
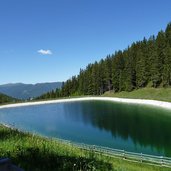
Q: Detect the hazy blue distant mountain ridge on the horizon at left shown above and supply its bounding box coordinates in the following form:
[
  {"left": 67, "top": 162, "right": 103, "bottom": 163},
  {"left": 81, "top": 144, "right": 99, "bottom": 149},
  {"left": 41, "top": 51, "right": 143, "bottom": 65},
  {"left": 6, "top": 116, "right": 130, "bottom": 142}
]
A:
[{"left": 0, "top": 82, "right": 62, "bottom": 99}]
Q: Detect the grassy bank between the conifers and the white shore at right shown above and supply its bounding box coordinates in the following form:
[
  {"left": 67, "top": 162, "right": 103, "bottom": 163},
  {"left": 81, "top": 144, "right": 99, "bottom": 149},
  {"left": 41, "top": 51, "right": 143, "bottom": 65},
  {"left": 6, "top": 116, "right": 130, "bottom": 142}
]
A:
[{"left": 103, "top": 88, "right": 171, "bottom": 102}]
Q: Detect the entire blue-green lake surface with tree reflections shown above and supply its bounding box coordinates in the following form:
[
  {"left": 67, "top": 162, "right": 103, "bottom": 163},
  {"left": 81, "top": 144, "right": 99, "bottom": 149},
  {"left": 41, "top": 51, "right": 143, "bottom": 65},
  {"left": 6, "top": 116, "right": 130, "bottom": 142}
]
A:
[{"left": 0, "top": 100, "right": 171, "bottom": 157}]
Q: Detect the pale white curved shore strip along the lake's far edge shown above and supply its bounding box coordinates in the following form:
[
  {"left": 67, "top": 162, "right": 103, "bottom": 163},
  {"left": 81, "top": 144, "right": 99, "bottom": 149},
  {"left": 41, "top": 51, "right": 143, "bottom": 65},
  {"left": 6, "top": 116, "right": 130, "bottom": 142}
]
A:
[{"left": 0, "top": 97, "right": 171, "bottom": 110}]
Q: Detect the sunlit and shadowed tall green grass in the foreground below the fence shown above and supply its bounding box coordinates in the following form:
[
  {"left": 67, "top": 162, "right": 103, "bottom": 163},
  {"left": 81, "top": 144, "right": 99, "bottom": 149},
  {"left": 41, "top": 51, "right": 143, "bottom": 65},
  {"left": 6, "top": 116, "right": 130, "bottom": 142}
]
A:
[{"left": 0, "top": 125, "right": 171, "bottom": 171}]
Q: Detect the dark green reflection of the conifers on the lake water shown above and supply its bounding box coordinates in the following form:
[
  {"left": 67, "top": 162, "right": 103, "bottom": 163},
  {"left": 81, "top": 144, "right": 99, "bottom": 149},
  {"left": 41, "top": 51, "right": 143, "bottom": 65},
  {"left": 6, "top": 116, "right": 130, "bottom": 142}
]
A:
[{"left": 64, "top": 101, "right": 171, "bottom": 156}]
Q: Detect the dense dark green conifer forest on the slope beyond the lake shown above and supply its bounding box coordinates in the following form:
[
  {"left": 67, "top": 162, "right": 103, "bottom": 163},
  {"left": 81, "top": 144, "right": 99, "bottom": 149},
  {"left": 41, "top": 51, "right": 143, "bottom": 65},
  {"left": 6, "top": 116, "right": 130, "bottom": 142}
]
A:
[{"left": 36, "top": 23, "right": 171, "bottom": 99}]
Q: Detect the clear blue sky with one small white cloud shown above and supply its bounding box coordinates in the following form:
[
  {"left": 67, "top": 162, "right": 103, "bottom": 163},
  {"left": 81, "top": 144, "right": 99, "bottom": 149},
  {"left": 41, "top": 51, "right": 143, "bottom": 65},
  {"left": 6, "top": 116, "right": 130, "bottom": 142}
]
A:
[{"left": 0, "top": 0, "right": 171, "bottom": 84}]
